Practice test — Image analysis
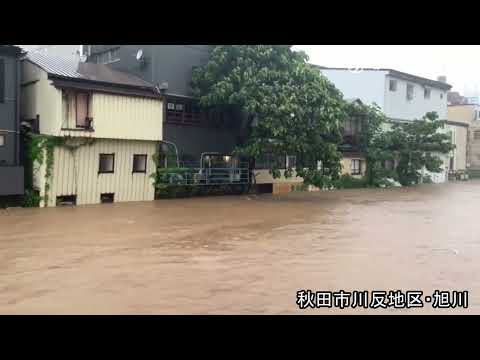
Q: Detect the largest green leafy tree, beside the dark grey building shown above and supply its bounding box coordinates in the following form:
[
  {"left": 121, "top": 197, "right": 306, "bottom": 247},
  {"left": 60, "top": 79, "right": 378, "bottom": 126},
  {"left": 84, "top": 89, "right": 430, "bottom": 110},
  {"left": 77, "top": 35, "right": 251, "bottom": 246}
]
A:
[{"left": 192, "top": 45, "right": 345, "bottom": 186}]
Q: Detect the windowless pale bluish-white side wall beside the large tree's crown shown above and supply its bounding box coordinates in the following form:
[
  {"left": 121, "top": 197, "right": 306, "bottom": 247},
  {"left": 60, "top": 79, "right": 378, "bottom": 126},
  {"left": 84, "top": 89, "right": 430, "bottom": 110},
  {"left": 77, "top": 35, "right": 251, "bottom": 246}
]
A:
[{"left": 320, "top": 69, "right": 387, "bottom": 110}]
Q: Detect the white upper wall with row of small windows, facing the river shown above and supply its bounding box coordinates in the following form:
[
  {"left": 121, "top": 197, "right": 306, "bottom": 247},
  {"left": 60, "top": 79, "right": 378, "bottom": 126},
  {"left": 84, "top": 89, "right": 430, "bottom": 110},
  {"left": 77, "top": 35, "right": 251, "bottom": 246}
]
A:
[{"left": 384, "top": 76, "right": 447, "bottom": 120}]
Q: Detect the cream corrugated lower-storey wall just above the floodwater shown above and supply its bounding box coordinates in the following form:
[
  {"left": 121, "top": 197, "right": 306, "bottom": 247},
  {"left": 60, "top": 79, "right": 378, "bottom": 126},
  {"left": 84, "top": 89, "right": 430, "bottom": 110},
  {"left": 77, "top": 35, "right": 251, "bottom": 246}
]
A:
[{"left": 42, "top": 139, "right": 158, "bottom": 206}]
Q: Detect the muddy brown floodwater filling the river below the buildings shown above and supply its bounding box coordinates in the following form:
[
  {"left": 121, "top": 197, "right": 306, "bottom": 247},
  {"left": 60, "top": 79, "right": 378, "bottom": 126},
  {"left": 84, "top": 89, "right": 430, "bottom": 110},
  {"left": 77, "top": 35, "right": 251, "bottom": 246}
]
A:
[{"left": 0, "top": 181, "right": 480, "bottom": 314}]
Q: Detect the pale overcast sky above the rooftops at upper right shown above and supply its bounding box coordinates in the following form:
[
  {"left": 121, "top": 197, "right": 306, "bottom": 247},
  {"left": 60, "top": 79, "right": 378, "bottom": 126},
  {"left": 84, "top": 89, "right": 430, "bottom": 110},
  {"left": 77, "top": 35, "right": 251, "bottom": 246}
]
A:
[{"left": 294, "top": 45, "right": 480, "bottom": 96}]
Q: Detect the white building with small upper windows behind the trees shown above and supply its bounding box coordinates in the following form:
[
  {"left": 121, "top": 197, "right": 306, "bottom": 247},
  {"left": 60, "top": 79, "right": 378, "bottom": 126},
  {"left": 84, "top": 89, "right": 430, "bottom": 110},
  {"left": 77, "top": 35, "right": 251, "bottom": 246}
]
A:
[{"left": 318, "top": 66, "right": 451, "bottom": 183}]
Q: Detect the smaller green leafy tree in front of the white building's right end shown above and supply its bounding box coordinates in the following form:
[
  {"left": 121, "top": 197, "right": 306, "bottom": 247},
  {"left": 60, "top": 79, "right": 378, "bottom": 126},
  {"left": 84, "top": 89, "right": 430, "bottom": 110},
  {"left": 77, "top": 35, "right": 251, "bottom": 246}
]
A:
[{"left": 382, "top": 112, "right": 455, "bottom": 185}]
